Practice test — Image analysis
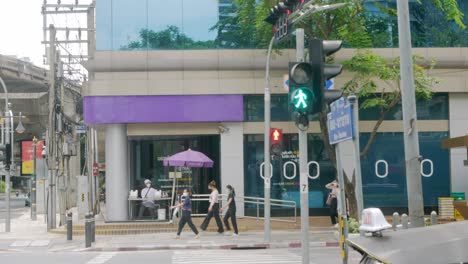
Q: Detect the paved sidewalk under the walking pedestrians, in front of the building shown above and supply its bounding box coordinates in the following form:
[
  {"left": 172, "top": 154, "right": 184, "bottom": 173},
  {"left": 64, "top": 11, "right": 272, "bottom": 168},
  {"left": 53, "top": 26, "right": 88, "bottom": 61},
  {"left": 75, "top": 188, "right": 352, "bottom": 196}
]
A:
[{"left": 0, "top": 212, "right": 338, "bottom": 252}]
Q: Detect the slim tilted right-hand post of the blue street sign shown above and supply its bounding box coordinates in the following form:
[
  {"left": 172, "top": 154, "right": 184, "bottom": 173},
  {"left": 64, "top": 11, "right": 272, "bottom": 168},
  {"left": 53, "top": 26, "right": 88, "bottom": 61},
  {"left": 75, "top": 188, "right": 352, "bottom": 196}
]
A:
[{"left": 348, "top": 94, "right": 364, "bottom": 224}]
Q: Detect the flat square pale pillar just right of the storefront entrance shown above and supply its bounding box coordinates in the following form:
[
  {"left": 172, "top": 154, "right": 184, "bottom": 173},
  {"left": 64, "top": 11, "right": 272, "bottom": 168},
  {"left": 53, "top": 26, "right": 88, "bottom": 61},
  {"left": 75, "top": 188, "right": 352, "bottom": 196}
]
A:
[{"left": 221, "top": 123, "right": 244, "bottom": 216}]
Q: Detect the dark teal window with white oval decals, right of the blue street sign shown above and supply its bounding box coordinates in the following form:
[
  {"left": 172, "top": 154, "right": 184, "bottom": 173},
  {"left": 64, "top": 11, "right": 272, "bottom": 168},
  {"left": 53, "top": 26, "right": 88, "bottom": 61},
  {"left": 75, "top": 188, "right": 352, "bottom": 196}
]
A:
[{"left": 360, "top": 132, "right": 450, "bottom": 207}]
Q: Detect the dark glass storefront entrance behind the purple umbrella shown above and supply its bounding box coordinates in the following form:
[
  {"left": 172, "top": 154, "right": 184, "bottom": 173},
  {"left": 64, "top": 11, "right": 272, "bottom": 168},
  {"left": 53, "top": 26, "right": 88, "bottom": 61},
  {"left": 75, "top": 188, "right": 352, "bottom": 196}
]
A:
[{"left": 129, "top": 135, "right": 220, "bottom": 216}]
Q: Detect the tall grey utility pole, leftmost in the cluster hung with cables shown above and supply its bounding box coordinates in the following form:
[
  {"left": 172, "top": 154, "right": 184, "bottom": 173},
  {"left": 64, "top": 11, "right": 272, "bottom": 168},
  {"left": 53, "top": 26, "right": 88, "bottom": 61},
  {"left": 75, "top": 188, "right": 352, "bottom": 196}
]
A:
[{"left": 47, "top": 25, "right": 57, "bottom": 229}]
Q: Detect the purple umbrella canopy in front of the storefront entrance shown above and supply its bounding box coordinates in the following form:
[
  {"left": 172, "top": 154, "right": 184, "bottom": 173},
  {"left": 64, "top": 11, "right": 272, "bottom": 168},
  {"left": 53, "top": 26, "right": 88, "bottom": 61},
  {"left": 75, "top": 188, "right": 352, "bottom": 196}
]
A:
[{"left": 164, "top": 149, "right": 213, "bottom": 168}]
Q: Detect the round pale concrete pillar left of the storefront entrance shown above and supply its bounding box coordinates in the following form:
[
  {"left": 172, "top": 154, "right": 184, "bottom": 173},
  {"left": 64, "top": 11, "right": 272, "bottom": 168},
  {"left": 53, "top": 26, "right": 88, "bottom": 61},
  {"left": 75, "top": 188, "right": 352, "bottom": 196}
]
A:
[{"left": 105, "top": 124, "right": 130, "bottom": 221}]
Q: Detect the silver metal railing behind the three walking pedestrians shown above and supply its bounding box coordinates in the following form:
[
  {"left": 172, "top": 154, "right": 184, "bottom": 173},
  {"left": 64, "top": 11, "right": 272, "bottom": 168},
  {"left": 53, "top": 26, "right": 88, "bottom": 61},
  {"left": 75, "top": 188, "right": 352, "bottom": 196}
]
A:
[{"left": 187, "top": 194, "right": 297, "bottom": 223}]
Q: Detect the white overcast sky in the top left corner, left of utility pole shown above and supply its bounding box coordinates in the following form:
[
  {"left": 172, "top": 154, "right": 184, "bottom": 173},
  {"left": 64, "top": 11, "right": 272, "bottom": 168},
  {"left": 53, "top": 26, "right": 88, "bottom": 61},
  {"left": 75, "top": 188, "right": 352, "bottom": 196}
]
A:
[{"left": 0, "top": 0, "right": 44, "bottom": 66}]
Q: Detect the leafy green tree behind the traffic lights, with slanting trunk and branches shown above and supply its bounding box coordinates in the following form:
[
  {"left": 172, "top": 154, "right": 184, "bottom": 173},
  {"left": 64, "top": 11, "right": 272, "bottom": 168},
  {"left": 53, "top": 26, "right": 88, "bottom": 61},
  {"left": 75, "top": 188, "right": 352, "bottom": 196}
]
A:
[{"left": 222, "top": 0, "right": 464, "bottom": 217}]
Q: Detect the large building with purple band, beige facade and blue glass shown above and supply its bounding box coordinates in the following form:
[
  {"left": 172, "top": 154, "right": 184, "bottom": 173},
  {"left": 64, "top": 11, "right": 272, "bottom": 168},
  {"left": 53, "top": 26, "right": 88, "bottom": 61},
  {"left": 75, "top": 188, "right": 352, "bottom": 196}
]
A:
[{"left": 88, "top": 0, "right": 468, "bottom": 217}]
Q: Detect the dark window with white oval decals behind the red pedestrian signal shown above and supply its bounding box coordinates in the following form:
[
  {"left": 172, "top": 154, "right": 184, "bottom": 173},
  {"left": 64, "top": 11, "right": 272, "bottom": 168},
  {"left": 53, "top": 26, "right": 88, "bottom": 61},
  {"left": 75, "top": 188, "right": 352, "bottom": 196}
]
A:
[{"left": 244, "top": 134, "right": 335, "bottom": 212}]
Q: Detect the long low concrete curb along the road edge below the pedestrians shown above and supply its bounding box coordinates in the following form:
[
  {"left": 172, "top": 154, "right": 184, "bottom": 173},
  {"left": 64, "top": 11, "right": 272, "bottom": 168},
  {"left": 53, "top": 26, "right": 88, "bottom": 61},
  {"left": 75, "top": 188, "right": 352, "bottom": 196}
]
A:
[{"left": 74, "top": 241, "right": 339, "bottom": 252}]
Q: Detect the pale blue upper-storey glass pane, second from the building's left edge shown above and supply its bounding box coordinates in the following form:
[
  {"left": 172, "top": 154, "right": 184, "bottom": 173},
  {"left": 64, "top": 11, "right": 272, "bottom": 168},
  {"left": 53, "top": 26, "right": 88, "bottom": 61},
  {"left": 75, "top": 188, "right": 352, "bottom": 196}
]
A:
[{"left": 112, "top": 0, "right": 148, "bottom": 50}]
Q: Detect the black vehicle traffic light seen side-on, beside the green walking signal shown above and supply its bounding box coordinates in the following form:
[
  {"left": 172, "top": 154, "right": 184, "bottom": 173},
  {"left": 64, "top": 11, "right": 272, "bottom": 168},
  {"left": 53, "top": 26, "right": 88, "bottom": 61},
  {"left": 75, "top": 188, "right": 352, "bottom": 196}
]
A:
[{"left": 309, "top": 39, "right": 343, "bottom": 107}]
